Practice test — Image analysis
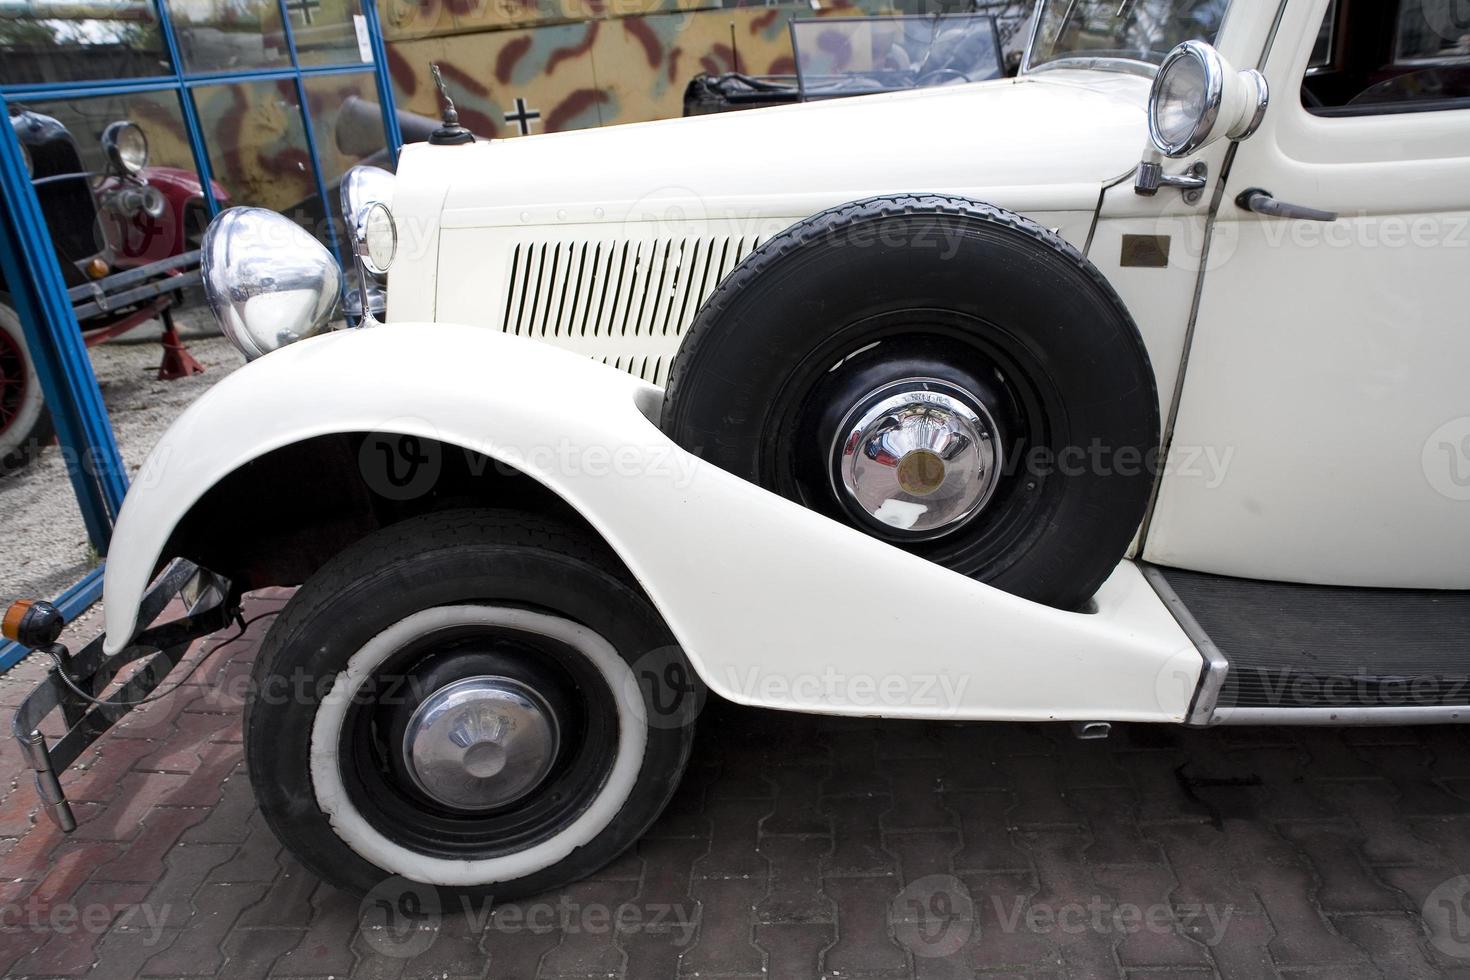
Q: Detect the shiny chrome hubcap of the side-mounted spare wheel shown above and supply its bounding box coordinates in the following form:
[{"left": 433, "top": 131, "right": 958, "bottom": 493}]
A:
[{"left": 832, "top": 378, "right": 1001, "bottom": 539}]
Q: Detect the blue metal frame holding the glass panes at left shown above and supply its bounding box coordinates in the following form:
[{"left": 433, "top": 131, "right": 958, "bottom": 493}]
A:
[{"left": 0, "top": 0, "right": 401, "bottom": 670}]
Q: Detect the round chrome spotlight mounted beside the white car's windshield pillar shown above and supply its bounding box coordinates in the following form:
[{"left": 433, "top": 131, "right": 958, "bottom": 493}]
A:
[{"left": 1148, "top": 41, "right": 1269, "bottom": 157}]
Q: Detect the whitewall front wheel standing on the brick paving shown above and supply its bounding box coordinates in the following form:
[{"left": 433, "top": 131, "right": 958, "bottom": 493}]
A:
[{"left": 245, "top": 511, "right": 698, "bottom": 899}]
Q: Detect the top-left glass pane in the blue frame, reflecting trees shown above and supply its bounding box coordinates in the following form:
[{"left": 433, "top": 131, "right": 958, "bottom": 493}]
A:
[{"left": 0, "top": 0, "right": 173, "bottom": 85}]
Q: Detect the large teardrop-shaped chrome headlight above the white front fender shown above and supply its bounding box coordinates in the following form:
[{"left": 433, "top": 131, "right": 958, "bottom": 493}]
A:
[{"left": 200, "top": 207, "right": 341, "bottom": 360}]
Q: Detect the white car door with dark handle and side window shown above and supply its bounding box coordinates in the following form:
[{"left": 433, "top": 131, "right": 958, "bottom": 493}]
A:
[{"left": 1144, "top": 0, "right": 1470, "bottom": 589}]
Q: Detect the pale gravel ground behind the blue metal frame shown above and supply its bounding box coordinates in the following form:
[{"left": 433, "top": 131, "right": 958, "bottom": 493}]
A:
[{"left": 0, "top": 306, "right": 245, "bottom": 607}]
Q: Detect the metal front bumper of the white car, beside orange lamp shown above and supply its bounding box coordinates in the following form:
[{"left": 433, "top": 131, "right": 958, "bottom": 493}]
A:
[{"left": 10, "top": 560, "right": 238, "bottom": 833}]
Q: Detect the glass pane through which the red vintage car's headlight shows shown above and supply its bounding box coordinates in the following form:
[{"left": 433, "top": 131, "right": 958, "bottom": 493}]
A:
[{"left": 10, "top": 91, "right": 207, "bottom": 283}]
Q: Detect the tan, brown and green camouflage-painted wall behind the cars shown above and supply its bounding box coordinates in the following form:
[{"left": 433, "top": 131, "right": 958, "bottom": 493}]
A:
[{"left": 0, "top": 0, "right": 1029, "bottom": 223}]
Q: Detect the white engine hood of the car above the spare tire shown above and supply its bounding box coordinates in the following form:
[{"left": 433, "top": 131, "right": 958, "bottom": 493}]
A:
[{"left": 388, "top": 71, "right": 1148, "bottom": 343}]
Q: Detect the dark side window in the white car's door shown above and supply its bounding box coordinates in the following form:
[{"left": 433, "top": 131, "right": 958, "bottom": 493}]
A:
[{"left": 1301, "top": 0, "right": 1470, "bottom": 116}]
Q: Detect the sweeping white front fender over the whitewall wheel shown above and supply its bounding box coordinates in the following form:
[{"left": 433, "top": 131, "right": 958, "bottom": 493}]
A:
[{"left": 104, "top": 323, "right": 1201, "bottom": 721}]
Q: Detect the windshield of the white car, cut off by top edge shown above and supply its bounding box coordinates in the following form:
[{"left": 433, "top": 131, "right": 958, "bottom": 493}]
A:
[{"left": 1026, "top": 0, "right": 1230, "bottom": 68}]
